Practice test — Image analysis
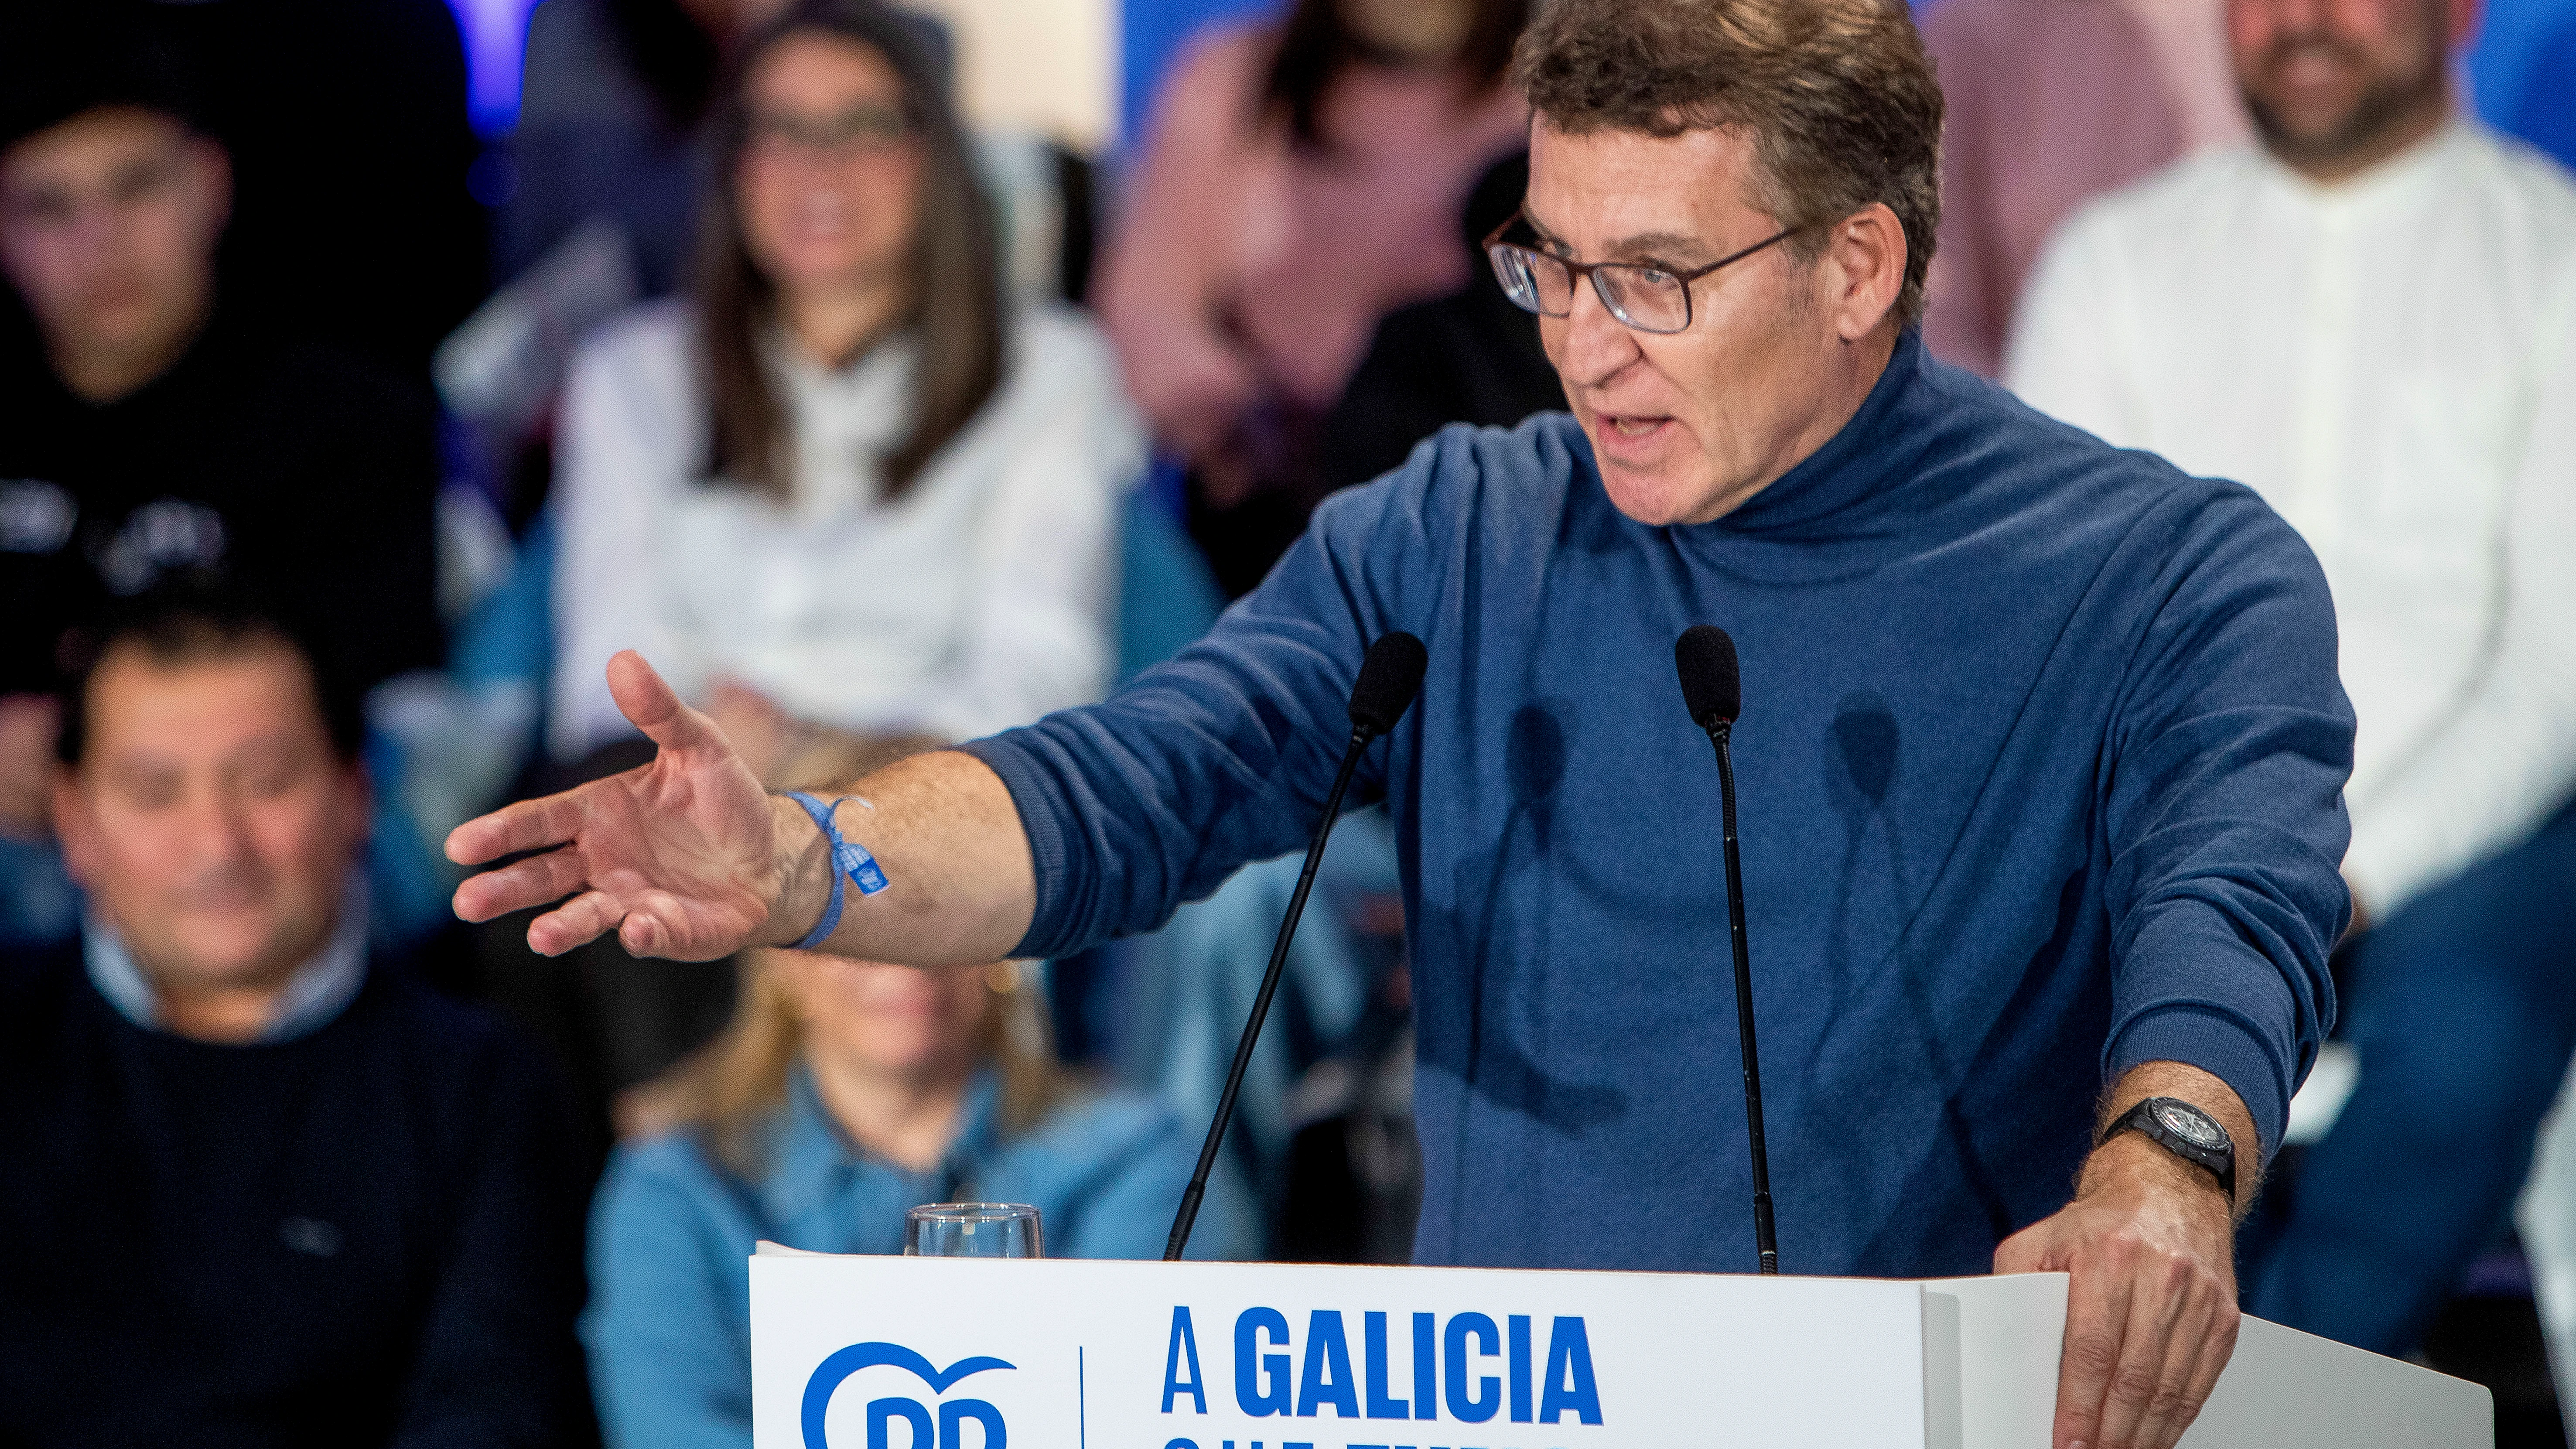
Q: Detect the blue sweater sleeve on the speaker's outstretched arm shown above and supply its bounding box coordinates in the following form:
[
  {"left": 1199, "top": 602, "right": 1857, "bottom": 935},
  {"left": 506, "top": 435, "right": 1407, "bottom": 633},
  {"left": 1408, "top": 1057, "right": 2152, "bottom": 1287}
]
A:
[{"left": 966, "top": 428, "right": 1473, "bottom": 957}]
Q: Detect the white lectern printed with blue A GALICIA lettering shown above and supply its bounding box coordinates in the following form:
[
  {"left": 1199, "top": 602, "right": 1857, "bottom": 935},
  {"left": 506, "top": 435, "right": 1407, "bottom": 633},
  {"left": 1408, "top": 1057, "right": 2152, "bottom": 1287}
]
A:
[{"left": 752, "top": 1248, "right": 2494, "bottom": 1449}]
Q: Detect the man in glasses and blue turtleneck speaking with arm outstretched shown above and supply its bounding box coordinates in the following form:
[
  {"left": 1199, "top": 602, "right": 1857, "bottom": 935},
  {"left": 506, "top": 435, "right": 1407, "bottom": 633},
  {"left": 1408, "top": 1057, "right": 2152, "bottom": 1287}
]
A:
[{"left": 448, "top": 0, "right": 2352, "bottom": 1449}]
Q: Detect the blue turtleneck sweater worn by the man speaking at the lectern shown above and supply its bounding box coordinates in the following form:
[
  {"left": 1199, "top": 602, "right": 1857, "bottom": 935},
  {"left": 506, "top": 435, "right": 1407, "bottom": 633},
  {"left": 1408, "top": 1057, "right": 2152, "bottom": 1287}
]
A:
[{"left": 974, "top": 335, "right": 2352, "bottom": 1276}]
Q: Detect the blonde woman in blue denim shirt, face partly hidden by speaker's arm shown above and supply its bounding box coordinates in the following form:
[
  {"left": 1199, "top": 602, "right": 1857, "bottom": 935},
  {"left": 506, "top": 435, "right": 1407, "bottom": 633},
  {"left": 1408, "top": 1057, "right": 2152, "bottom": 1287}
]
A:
[{"left": 582, "top": 951, "right": 1247, "bottom": 1449}]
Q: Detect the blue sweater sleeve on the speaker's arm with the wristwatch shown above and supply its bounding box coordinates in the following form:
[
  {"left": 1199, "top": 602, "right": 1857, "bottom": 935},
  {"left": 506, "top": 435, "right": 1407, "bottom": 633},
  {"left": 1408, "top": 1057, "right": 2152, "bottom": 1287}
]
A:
[{"left": 2102, "top": 479, "right": 2352, "bottom": 1155}]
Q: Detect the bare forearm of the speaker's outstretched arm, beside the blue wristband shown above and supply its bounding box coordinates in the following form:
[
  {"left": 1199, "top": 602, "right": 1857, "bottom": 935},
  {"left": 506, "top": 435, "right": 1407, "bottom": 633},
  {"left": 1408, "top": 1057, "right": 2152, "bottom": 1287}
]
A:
[{"left": 760, "top": 750, "right": 1038, "bottom": 967}]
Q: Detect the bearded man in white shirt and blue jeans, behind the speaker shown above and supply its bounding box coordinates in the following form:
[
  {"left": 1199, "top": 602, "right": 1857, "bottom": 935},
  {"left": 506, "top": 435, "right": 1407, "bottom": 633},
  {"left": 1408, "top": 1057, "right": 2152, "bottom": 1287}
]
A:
[{"left": 2009, "top": 0, "right": 2576, "bottom": 1353}]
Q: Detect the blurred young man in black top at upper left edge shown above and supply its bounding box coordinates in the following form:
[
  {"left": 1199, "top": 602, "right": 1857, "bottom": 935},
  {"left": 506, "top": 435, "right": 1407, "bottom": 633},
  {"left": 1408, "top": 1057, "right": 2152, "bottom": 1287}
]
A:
[{"left": 0, "top": 8, "right": 441, "bottom": 923}]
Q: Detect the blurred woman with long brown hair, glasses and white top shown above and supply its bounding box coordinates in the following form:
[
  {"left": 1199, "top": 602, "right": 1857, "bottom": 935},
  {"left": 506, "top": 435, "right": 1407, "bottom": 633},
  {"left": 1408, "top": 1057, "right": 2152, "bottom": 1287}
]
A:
[{"left": 551, "top": 0, "right": 1144, "bottom": 781}]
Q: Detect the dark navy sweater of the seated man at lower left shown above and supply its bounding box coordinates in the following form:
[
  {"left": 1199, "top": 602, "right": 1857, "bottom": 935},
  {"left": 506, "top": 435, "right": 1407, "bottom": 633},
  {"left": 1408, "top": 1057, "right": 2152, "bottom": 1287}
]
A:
[{"left": 0, "top": 946, "right": 590, "bottom": 1449}]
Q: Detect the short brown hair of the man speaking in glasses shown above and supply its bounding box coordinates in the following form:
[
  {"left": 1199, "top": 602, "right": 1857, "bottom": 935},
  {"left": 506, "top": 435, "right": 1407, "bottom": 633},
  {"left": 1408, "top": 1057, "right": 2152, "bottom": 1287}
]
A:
[{"left": 1512, "top": 0, "right": 1942, "bottom": 325}]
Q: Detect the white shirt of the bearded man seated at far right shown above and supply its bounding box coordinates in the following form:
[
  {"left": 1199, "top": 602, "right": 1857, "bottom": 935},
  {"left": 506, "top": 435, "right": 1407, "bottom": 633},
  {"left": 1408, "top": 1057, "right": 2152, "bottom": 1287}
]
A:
[{"left": 2004, "top": 121, "right": 2576, "bottom": 915}]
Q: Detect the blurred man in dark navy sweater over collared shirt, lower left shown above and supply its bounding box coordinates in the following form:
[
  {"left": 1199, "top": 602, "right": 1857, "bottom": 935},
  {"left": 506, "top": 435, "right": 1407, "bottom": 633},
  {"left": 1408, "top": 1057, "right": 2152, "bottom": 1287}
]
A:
[{"left": 0, "top": 595, "right": 588, "bottom": 1446}]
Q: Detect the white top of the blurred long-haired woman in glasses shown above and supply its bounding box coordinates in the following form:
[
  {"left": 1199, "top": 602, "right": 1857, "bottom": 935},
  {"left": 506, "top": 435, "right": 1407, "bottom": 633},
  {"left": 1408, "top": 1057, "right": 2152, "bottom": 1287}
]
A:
[{"left": 549, "top": 302, "right": 1144, "bottom": 758}]
